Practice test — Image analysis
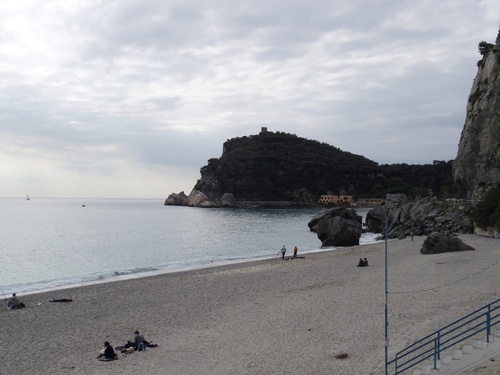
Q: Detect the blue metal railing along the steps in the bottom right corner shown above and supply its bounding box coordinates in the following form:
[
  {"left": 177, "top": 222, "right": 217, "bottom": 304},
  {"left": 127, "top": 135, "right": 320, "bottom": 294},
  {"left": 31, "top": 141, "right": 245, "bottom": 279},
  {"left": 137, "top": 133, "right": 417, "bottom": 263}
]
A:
[{"left": 386, "top": 299, "right": 500, "bottom": 375}]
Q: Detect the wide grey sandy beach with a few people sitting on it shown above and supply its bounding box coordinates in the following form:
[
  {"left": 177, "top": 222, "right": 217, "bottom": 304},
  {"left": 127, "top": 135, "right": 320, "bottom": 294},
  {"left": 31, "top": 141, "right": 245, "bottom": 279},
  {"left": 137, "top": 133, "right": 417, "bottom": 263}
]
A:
[{"left": 0, "top": 235, "right": 500, "bottom": 375}]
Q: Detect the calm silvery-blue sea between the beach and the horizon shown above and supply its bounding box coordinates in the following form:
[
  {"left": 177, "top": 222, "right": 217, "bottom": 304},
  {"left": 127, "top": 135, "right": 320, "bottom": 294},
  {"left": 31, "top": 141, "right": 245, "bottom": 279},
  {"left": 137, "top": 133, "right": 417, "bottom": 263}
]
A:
[{"left": 0, "top": 198, "right": 374, "bottom": 295}]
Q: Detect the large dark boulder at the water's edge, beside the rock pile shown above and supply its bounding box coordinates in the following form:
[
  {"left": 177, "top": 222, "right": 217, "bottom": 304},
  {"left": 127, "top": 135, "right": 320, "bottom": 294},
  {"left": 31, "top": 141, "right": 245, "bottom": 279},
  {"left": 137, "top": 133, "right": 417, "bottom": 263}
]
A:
[{"left": 307, "top": 207, "right": 363, "bottom": 247}]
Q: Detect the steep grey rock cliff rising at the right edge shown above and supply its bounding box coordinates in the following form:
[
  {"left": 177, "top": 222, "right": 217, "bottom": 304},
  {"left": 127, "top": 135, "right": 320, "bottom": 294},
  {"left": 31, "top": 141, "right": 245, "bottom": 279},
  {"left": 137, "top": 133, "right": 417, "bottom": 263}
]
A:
[{"left": 453, "top": 32, "right": 500, "bottom": 199}]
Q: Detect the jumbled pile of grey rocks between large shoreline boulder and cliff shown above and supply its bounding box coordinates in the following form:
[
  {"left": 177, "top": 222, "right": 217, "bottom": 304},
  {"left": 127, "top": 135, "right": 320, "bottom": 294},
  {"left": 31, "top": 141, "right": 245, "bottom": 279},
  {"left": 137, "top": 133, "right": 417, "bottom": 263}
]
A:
[{"left": 365, "top": 194, "right": 474, "bottom": 239}]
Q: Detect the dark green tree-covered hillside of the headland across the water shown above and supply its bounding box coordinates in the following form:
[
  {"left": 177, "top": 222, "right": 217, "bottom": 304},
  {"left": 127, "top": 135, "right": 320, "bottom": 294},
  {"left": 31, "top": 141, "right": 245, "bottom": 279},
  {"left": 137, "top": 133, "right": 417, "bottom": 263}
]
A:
[{"left": 195, "top": 132, "right": 455, "bottom": 201}]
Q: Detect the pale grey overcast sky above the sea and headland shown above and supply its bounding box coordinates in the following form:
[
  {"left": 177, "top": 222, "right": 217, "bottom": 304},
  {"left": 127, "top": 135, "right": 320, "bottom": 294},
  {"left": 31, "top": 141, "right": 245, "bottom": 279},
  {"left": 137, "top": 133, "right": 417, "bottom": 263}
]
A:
[{"left": 0, "top": 0, "right": 500, "bottom": 199}]
